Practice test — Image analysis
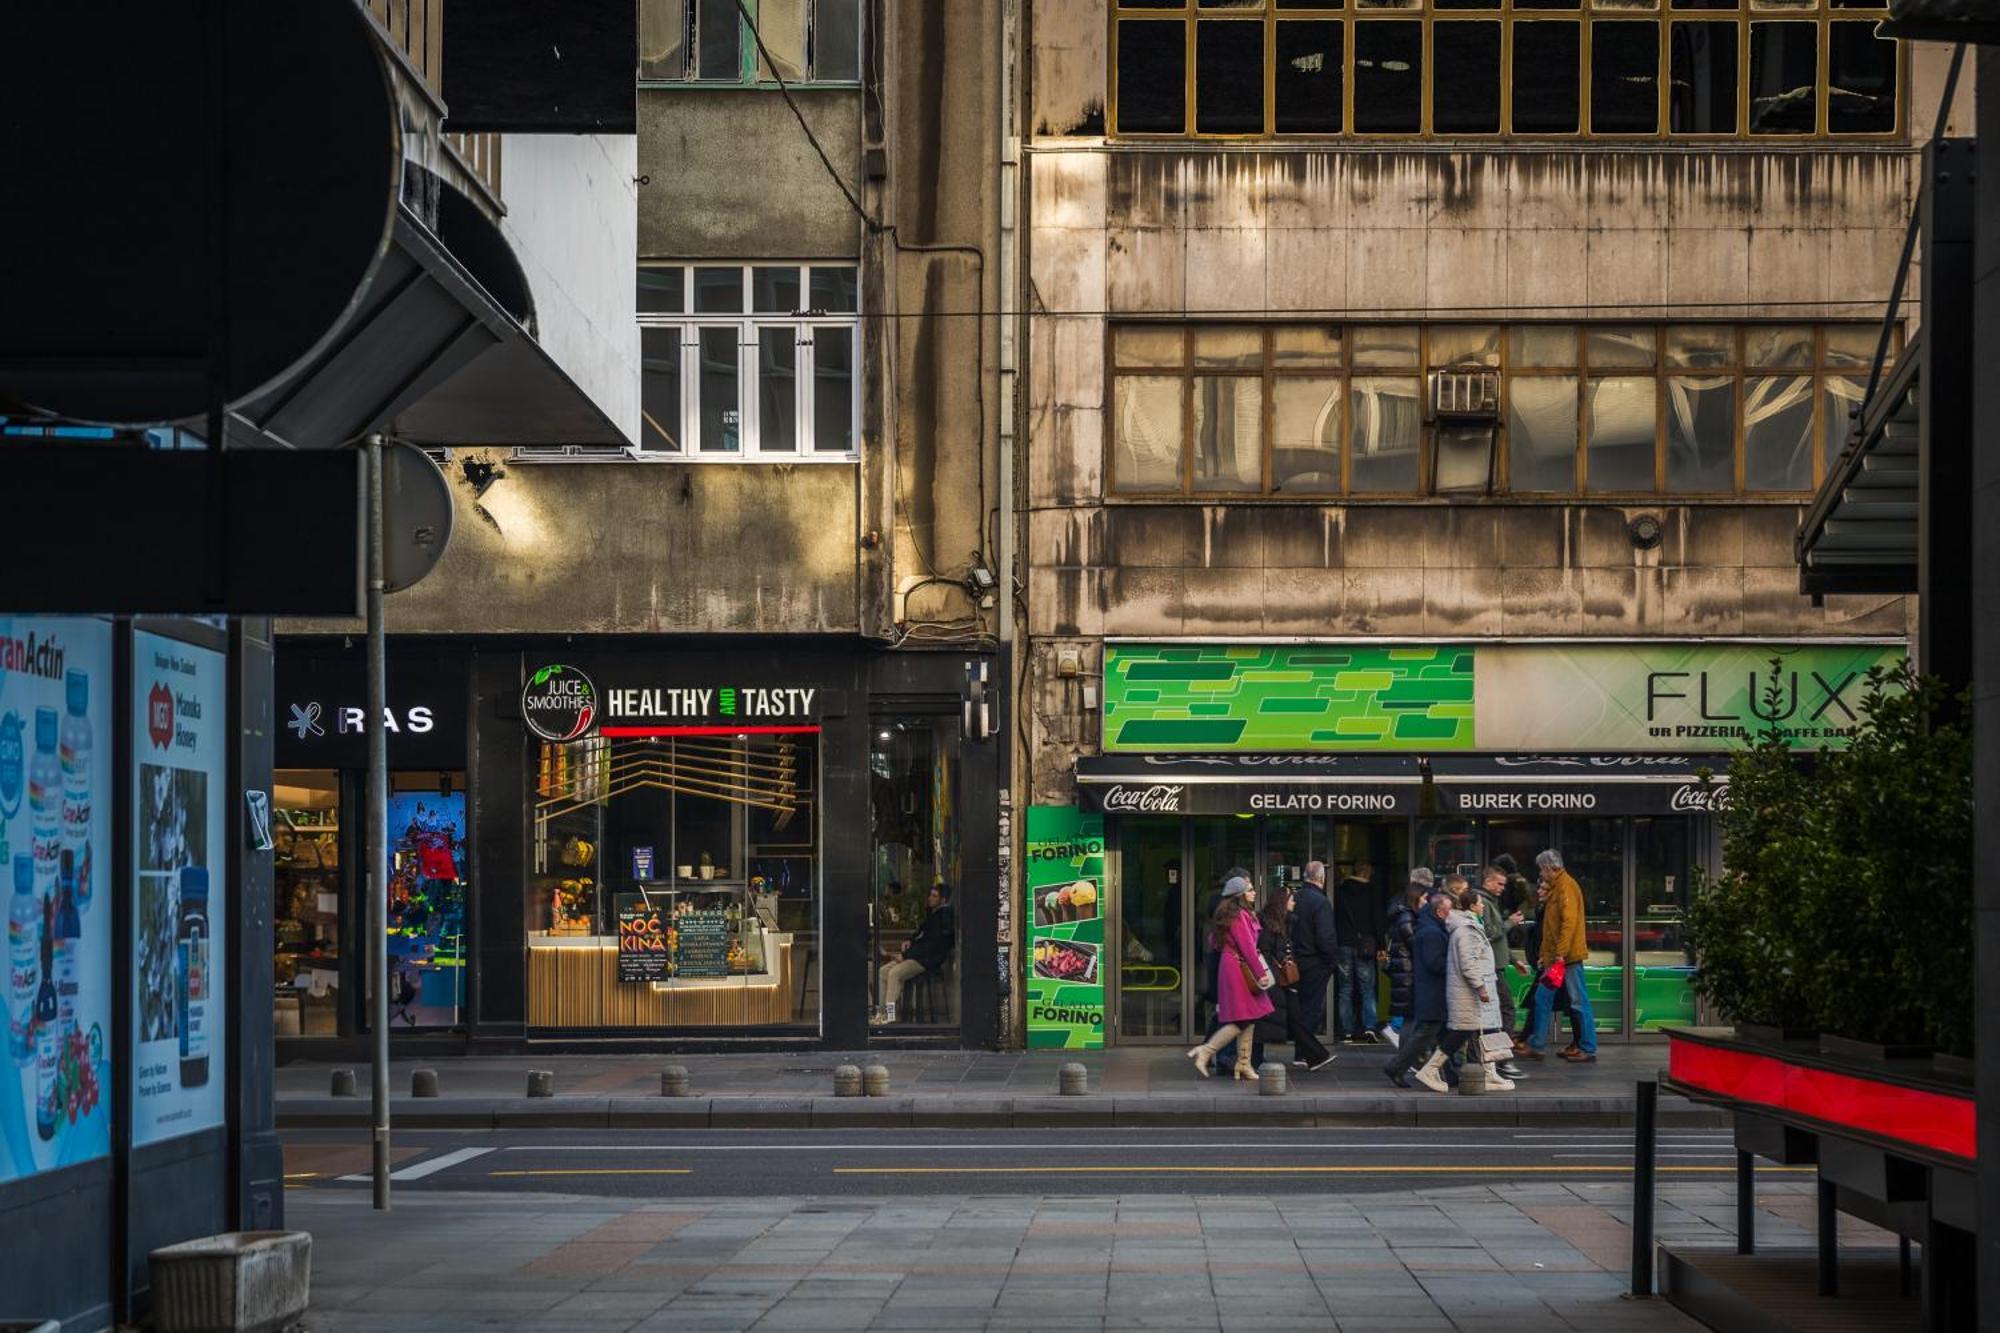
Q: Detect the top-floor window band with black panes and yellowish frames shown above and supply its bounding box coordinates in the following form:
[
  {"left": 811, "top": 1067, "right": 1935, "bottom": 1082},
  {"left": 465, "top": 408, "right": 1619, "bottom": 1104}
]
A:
[{"left": 1120, "top": 0, "right": 1902, "bottom": 138}]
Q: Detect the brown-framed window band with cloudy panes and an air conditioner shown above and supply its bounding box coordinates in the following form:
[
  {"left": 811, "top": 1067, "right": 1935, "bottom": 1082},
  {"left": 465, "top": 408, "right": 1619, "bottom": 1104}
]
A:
[{"left": 1106, "top": 324, "right": 1878, "bottom": 498}]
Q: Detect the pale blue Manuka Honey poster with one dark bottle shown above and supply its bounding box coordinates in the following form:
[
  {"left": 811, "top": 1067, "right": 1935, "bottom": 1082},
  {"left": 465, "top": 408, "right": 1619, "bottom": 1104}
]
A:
[{"left": 132, "top": 632, "right": 230, "bottom": 1143}]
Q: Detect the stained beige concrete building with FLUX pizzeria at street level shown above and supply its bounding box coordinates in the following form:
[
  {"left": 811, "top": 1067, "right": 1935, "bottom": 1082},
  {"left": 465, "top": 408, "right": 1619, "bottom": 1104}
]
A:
[{"left": 1018, "top": 0, "right": 1970, "bottom": 1047}]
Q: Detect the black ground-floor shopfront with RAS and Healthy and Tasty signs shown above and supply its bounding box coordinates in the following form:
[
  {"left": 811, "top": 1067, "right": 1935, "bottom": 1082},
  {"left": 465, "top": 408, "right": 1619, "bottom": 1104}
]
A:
[{"left": 272, "top": 636, "right": 1004, "bottom": 1057}]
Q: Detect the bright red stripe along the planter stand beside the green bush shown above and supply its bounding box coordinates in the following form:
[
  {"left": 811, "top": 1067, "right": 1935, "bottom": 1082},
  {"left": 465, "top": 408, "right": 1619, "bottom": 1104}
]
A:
[{"left": 1666, "top": 1041, "right": 1980, "bottom": 1161}]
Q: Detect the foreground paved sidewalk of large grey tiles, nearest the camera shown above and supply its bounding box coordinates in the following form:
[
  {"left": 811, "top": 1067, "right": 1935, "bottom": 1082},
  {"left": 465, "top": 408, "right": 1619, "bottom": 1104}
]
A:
[{"left": 286, "top": 1181, "right": 1886, "bottom": 1333}]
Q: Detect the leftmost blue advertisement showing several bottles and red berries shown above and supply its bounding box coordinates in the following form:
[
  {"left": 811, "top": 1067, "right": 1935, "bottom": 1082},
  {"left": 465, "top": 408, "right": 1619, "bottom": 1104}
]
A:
[{"left": 0, "top": 616, "right": 112, "bottom": 1183}]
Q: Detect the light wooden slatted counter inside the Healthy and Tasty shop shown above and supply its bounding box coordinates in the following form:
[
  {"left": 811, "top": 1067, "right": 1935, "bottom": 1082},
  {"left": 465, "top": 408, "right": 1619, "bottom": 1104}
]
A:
[{"left": 528, "top": 933, "right": 792, "bottom": 1027}]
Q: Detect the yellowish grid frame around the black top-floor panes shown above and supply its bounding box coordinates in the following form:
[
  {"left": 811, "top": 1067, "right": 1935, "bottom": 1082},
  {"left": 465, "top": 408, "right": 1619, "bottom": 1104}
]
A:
[{"left": 1106, "top": 0, "right": 1910, "bottom": 144}]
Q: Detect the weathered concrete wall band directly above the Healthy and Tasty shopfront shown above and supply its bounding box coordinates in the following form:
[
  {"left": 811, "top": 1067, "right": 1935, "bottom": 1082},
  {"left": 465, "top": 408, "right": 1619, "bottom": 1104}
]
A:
[{"left": 278, "top": 462, "right": 856, "bottom": 634}]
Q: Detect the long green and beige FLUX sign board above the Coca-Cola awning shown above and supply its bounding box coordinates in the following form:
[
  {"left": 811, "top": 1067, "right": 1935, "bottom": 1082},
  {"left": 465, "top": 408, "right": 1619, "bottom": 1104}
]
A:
[{"left": 1104, "top": 642, "right": 1904, "bottom": 753}]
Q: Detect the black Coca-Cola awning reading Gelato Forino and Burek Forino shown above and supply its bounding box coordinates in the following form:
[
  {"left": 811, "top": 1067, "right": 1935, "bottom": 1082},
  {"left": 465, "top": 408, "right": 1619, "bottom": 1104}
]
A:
[{"left": 1076, "top": 755, "right": 1728, "bottom": 817}]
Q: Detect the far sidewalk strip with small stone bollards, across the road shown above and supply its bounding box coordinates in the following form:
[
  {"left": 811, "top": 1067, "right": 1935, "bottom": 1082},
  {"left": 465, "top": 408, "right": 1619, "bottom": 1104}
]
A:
[{"left": 278, "top": 1045, "right": 1722, "bottom": 1129}]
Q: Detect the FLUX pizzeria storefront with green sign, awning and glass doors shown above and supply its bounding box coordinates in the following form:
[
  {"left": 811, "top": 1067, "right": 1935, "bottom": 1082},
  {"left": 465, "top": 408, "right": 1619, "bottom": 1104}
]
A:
[{"left": 1028, "top": 642, "right": 1902, "bottom": 1047}]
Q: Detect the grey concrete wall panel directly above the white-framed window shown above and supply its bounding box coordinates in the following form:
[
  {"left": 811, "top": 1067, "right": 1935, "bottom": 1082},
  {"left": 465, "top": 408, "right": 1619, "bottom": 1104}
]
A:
[{"left": 638, "top": 88, "right": 862, "bottom": 260}]
